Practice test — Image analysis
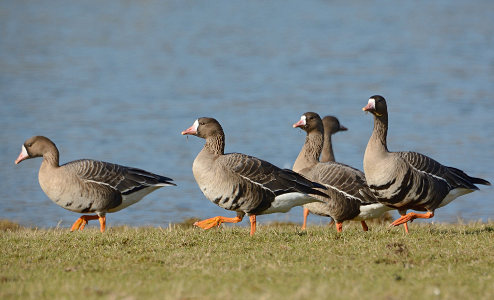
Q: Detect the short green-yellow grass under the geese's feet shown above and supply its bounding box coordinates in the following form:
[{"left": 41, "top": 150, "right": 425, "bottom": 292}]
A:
[{"left": 0, "top": 219, "right": 494, "bottom": 299}]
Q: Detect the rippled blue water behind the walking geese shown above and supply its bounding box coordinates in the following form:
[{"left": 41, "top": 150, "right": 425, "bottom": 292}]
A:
[{"left": 0, "top": 0, "right": 494, "bottom": 227}]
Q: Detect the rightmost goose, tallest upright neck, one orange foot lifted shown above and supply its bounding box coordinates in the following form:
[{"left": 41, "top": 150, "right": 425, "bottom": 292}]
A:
[{"left": 362, "top": 95, "right": 490, "bottom": 232}]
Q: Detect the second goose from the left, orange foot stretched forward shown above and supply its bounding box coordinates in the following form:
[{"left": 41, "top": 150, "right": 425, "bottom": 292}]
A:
[{"left": 182, "top": 118, "right": 326, "bottom": 235}]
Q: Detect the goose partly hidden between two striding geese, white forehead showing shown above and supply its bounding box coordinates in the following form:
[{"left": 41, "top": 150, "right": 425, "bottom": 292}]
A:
[{"left": 293, "top": 112, "right": 390, "bottom": 232}]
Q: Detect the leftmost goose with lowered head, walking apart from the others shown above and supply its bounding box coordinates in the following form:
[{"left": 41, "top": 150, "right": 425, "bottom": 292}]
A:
[{"left": 15, "top": 136, "right": 175, "bottom": 232}]
